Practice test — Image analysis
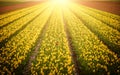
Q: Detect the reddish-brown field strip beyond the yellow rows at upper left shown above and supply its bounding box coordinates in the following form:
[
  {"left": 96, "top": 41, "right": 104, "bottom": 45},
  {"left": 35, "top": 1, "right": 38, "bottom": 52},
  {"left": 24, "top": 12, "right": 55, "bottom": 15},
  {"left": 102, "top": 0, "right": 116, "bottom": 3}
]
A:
[{"left": 0, "top": 2, "right": 42, "bottom": 14}]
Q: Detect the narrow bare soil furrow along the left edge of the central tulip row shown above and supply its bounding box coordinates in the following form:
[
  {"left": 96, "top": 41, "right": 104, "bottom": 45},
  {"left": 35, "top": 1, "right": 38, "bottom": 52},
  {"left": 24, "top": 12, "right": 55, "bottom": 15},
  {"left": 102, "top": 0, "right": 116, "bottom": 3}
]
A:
[{"left": 23, "top": 10, "right": 52, "bottom": 75}]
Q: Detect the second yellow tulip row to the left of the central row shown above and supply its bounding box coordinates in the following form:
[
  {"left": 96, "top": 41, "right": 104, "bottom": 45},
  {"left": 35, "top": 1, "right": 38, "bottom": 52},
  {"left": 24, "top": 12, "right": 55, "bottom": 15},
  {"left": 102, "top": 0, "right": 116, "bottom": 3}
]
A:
[{"left": 0, "top": 5, "right": 47, "bottom": 42}]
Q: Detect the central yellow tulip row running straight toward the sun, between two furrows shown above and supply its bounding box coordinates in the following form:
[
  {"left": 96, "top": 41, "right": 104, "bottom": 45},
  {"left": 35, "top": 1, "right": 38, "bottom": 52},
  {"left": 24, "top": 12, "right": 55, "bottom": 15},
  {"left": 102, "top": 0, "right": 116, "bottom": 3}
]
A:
[{"left": 31, "top": 6, "right": 74, "bottom": 75}]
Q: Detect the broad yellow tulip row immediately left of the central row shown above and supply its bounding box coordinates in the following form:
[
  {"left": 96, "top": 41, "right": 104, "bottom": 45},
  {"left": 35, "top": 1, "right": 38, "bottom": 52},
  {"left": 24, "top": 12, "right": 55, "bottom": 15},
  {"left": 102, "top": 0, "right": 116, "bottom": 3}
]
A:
[{"left": 0, "top": 4, "right": 52, "bottom": 75}]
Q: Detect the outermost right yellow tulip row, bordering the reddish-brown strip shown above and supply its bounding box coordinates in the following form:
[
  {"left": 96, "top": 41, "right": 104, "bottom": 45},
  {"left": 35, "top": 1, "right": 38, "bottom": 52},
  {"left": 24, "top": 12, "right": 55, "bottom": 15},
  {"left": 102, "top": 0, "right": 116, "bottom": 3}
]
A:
[{"left": 72, "top": 5, "right": 120, "bottom": 31}]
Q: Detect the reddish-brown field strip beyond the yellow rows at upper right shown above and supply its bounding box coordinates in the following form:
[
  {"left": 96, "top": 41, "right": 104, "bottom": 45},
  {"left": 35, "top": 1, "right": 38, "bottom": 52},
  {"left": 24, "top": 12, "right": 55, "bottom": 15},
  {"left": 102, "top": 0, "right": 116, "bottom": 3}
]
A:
[{"left": 77, "top": 1, "right": 120, "bottom": 15}]
